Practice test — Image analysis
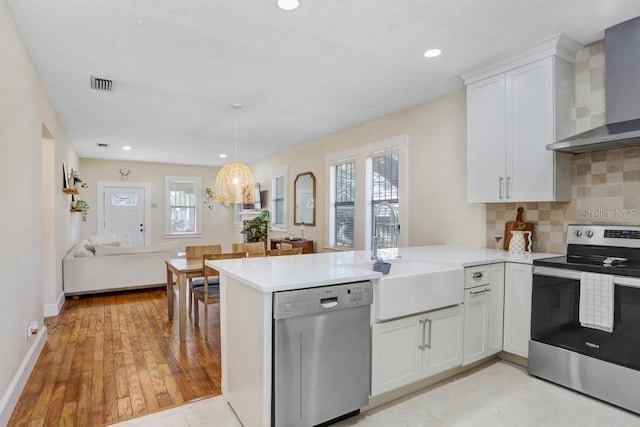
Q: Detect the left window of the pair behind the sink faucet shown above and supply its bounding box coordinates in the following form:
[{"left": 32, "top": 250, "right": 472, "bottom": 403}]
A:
[{"left": 330, "top": 159, "right": 356, "bottom": 248}]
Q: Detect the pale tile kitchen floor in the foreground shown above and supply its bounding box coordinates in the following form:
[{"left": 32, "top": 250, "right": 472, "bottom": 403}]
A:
[{"left": 112, "top": 361, "right": 640, "bottom": 427}]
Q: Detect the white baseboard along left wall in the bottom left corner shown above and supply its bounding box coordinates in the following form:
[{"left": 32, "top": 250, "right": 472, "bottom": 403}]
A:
[{"left": 0, "top": 325, "right": 47, "bottom": 426}]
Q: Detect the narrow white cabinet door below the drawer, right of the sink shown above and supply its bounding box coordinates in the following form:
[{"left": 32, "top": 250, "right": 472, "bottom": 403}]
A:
[{"left": 462, "top": 286, "right": 491, "bottom": 365}]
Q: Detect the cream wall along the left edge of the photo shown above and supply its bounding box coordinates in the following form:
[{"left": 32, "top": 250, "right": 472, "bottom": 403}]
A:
[{"left": 0, "top": 0, "right": 77, "bottom": 425}]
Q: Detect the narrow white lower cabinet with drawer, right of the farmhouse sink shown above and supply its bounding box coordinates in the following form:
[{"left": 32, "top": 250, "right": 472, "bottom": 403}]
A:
[{"left": 462, "top": 263, "right": 504, "bottom": 365}]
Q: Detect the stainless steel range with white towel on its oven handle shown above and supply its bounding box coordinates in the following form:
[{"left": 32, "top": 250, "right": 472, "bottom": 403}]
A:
[{"left": 528, "top": 225, "right": 640, "bottom": 413}]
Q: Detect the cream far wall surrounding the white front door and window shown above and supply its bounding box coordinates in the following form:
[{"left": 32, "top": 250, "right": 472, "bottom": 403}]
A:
[{"left": 76, "top": 159, "right": 242, "bottom": 251}]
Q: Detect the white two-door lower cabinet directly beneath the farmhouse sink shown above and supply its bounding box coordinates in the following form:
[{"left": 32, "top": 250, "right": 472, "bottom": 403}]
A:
[{"left": 371, "top": 305, "right": 463, "bottom": 396}]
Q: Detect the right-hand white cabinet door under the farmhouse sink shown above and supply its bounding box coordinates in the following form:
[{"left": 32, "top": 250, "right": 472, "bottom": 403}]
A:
[{"left": 422, "top": 305, "right": 463, "bottom": 377}]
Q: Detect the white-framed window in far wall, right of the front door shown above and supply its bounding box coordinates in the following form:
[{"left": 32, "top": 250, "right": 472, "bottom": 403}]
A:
[{"left": 166, "top": 177, "right": 200, "bottom": 235}]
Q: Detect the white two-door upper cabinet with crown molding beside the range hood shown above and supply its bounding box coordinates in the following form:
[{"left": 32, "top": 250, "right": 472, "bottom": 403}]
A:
[{"left": 462, "top": 36, "right": 580, "bottom": 203}]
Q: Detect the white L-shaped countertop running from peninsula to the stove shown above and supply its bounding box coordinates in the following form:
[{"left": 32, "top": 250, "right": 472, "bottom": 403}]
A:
[{"left": 207, "top": 245, "right": 558, "bottom": 293}]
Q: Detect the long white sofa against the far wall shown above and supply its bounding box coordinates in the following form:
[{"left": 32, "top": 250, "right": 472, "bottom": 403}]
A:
[{"left": 62, "top": 236, "right": 178, "bottom": 295}]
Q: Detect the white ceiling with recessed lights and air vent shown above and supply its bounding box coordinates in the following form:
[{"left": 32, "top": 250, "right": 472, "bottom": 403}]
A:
[{"left": 7, "top": 0, "right": 640, "bottom": 165}]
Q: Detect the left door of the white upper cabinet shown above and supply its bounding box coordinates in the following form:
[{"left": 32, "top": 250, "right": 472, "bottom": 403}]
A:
[{"left": 467, "top": 74, "right": 506, "bottom": 203}]
